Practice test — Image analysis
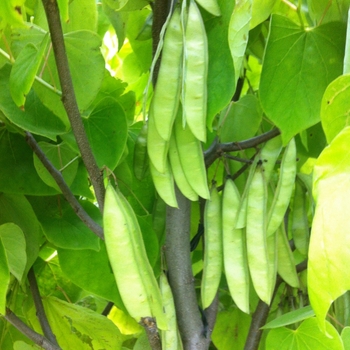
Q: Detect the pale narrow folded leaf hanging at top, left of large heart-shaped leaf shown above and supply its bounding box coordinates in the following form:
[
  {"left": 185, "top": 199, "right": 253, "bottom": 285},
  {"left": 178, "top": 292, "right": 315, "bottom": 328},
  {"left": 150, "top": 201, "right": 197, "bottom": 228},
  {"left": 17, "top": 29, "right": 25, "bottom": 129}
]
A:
[{"left": 228, "top": 0, "right": 255, "bottom": 83}]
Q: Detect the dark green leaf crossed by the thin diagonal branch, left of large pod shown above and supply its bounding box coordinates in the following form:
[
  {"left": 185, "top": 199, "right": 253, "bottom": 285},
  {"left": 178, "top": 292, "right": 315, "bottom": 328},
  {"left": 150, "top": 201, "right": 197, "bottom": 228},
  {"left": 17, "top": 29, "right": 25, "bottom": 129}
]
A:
[{"left": 29, "top": 196, "right": 102, "bottom": 251}]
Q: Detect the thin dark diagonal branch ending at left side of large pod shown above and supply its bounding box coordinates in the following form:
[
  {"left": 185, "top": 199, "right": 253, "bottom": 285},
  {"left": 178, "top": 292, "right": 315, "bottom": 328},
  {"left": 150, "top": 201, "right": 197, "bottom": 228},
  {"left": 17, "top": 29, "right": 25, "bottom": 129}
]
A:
[{"left": 25, "top": 132, "right": 103, "bottom": 239}]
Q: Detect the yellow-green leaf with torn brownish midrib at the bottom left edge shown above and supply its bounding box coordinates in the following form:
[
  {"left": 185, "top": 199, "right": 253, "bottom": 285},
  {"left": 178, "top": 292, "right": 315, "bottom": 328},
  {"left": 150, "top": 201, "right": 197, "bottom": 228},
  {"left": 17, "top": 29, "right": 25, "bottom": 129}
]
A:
[{"left": 38, "top": 297, "right": 124, "bottom": 350}]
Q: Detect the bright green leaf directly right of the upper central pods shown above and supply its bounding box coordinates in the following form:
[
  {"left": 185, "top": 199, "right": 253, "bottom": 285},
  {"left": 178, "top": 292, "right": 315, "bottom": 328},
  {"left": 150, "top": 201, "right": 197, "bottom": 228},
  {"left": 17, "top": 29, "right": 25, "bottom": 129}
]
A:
[{"left": 204, "top": 0, "right": 236, "bottom": 131}]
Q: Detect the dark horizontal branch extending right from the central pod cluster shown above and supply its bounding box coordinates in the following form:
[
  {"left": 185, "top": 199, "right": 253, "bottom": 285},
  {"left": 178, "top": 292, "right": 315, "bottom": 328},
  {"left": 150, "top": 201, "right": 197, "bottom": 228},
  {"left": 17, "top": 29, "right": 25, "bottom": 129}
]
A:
[{"left": 204, "top": 129, "right": 281, "bottom": 168}]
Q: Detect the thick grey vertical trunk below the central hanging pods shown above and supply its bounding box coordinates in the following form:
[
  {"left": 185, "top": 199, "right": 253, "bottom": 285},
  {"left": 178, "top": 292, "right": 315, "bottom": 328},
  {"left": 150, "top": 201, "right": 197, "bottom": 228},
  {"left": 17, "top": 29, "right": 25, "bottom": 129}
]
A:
[{"left": 165, "top": 186, "right": 207, "bottom": 350}]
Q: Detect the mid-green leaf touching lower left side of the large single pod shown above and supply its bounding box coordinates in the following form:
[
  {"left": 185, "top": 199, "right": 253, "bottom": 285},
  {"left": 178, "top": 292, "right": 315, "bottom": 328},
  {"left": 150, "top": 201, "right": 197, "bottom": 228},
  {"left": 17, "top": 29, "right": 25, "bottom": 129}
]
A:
[{"left": 57, "top": 242, "right": 125, "bottom": 311}]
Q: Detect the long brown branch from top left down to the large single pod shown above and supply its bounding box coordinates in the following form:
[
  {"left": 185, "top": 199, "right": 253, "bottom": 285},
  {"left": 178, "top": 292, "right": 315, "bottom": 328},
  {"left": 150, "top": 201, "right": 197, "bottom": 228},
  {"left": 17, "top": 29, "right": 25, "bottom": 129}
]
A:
[{"left": 42, "top": 0, "right": 105, "bottom": 212}]
